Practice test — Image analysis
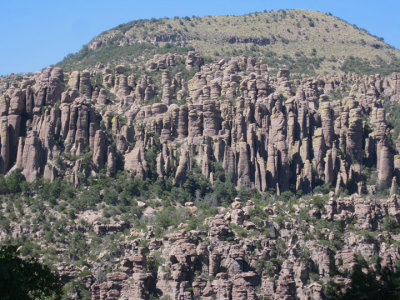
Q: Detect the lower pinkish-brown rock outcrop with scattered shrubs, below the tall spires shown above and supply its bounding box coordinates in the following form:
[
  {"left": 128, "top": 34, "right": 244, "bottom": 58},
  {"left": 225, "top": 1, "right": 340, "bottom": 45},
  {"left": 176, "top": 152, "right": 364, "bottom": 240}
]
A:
[{"left": 86, "top": 195, "right": 400, "bottom": 300}]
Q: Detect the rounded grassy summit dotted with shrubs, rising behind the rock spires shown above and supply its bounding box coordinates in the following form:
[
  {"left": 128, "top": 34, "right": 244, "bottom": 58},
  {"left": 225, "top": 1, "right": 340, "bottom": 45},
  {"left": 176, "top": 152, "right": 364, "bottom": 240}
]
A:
[{"left": 57, "top": 10, "right": 400, "bottom": 75}]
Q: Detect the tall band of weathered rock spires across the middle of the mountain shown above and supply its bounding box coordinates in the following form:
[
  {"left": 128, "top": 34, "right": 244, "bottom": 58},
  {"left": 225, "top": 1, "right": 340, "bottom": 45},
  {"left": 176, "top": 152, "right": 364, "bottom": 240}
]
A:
[{"left": 0, "top": 52, "right": 400, "bottom": 194}]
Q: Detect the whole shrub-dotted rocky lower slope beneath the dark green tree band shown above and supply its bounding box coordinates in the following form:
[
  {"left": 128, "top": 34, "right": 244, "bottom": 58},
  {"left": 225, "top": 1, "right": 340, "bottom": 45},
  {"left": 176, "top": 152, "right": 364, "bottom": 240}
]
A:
[{"left": 1, "top": 183, "right": 400, "bottom": 300}]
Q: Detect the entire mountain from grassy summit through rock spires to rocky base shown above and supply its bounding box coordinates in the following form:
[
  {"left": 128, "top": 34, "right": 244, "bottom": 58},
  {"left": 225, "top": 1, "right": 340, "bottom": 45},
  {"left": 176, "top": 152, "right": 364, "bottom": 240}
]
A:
[{"left": 0, "top": 11, "right": 400, "bottom": 300}]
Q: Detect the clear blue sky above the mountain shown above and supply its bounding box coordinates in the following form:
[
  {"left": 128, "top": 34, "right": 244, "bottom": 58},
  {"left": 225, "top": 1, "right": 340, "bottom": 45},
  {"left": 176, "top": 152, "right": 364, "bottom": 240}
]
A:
[{"left": 0, "top": 0, "right": 400, "bottom": 75}]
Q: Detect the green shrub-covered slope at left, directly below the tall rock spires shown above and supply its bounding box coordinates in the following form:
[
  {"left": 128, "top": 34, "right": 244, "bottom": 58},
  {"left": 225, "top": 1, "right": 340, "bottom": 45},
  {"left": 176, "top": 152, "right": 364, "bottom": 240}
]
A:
[{"left": 0, "top": 164, "right": 244, "bottom": 299}]
